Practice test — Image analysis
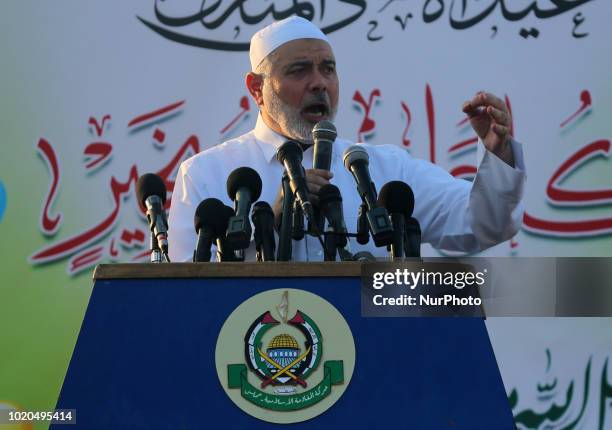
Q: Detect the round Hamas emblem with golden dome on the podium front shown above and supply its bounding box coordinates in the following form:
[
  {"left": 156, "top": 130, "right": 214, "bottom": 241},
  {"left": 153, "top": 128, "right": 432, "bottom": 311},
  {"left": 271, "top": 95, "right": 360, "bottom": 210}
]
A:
[{"left": 216, "top": 290, "right": 355, "bottom": 422}]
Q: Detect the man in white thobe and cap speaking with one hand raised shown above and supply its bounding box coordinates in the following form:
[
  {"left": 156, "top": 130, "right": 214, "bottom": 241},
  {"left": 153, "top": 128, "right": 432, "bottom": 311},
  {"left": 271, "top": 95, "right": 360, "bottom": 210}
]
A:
[{"left": 169, "top": 17, "right": 525, "bottom": 261}]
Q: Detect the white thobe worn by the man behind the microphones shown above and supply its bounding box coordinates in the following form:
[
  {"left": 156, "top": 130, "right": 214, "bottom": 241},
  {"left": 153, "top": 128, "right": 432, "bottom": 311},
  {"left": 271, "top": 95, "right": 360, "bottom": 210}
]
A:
[{"left": 168, "top": 116, "right": 525, "bottom": 261}]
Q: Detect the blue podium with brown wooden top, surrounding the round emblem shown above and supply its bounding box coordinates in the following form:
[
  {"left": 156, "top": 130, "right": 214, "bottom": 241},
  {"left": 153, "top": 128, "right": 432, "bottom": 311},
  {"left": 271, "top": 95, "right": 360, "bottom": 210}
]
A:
[{"left": 52, "top": 262, "right": 515, "bottom": 430}]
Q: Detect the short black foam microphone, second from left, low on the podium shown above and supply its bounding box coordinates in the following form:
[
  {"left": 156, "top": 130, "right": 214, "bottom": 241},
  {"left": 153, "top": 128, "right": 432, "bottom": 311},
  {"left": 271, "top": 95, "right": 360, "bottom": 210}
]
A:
[{"left": 193, "top": 198, "right": 225, "bottom": 262}]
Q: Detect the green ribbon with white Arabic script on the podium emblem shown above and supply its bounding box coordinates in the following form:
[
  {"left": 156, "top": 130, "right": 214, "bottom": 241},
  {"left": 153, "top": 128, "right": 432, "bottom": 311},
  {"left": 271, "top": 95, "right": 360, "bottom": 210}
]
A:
[{"left": 227, "top": 360, "right": 344, "bottom": 411}]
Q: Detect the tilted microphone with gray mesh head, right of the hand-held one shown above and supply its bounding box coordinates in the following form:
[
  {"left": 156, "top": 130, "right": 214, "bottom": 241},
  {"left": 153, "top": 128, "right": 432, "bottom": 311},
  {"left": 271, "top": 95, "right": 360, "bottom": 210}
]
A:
[{"left": 343, "top": 145, "right": 393, "bottom": 246}]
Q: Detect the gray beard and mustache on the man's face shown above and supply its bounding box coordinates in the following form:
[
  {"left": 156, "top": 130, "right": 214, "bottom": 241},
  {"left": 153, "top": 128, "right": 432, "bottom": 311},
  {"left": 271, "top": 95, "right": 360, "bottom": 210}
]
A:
[{"left": 263, "top": 85, "right": 337, "bottom": 145}]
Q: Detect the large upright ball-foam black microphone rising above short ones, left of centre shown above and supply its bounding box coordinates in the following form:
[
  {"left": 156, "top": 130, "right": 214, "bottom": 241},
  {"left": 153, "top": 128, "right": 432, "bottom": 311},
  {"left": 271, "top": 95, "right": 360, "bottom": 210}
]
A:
[{"left": 227, "top": 167, "right": 261, "bottom": 250}]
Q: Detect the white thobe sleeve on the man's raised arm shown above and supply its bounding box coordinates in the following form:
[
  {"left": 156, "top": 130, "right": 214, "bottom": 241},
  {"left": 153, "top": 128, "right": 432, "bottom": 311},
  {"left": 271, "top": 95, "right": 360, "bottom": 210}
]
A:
[{"left": 403, "top": 141, "right": 525, "bottom": 252}]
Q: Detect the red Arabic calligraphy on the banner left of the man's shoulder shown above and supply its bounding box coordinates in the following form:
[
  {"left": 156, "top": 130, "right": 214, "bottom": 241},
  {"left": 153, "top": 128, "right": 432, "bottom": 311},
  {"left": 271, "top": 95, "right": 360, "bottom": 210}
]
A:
[{"left": 29, "top": 100, "right": 200, "bottom": 275}]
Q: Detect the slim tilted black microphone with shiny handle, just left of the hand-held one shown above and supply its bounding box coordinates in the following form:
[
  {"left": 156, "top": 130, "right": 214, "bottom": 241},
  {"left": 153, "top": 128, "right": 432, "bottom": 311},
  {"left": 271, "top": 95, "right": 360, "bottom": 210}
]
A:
[{"left": 276, "top": 140, "right": 314, "bottom": 230}]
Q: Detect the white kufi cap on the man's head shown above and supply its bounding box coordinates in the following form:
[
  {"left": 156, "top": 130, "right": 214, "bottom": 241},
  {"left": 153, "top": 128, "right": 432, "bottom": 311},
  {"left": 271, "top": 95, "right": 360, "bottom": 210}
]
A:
[{"left": 249, "top": 16, "right": 329, "bottom": 71}]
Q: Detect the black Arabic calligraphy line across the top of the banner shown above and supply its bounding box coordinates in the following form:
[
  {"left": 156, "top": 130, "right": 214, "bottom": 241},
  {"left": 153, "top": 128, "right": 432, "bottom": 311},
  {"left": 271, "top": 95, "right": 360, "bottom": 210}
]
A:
[{"left": 136, "top": 0, "right": 593, "bottom": 52}]
